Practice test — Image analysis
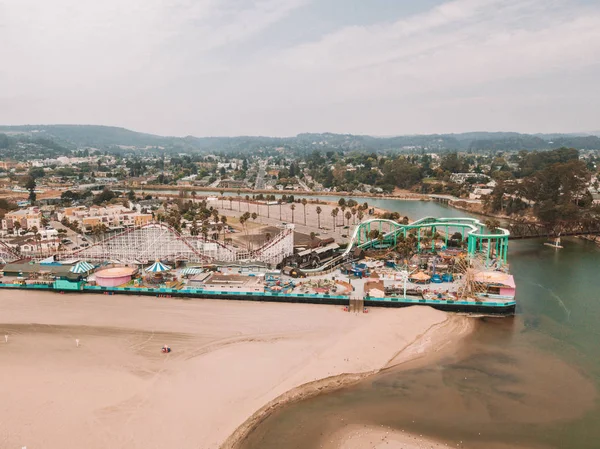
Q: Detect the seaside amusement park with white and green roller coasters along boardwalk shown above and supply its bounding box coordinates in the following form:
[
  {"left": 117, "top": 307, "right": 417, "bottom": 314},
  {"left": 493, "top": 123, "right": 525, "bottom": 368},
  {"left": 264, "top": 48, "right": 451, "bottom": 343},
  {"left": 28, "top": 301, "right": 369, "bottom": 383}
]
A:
[{"left": 0, "top": 217, "right": 516, "bottom": 315}]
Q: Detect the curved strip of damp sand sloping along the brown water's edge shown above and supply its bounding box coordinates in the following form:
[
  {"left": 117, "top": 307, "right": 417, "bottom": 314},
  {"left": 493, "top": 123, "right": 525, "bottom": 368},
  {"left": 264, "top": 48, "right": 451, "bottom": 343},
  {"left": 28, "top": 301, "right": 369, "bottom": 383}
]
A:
[{"left": 221, "top": 314, "right": 475, "bottom": 449}]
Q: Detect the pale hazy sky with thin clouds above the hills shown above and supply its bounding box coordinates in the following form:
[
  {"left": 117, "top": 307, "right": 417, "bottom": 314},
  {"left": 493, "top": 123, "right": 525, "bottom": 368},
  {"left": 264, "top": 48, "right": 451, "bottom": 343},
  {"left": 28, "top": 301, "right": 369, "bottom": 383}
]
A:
[{"left": 0, "top": 0, "right": 600, "bottom": 136}]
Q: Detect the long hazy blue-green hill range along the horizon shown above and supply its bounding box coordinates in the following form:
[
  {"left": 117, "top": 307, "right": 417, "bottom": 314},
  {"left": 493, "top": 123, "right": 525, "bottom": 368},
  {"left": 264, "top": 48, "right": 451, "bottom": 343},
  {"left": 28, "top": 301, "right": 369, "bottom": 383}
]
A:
[{"left": 0, "top": 125, "right": 600, "bottom": 152}]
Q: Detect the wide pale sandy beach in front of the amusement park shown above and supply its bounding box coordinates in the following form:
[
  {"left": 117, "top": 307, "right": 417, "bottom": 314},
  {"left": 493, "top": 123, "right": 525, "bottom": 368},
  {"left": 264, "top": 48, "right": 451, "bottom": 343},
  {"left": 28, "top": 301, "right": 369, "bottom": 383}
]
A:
[{"left": 0, "top": 291, "right": 460, "bottom": 449}]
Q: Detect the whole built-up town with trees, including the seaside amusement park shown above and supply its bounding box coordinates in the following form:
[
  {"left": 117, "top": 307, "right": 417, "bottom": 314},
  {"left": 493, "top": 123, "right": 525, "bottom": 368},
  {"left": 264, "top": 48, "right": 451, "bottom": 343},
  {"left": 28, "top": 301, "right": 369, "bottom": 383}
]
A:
[{"left": 0, "top": 127, "right": 599, "bottom": 313}]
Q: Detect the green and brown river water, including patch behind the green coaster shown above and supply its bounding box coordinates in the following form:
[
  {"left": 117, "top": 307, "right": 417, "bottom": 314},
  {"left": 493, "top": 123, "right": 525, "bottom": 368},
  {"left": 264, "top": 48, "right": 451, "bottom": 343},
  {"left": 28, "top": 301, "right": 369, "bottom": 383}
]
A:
[{"left": 238, "top": 200, "right": 600, "bottom": 449}]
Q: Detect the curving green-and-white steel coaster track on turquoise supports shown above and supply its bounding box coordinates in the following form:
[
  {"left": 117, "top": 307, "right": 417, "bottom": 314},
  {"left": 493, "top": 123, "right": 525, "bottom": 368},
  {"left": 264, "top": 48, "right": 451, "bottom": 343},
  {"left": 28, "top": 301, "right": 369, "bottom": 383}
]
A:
[{"left": 302, "top": 217, "right": 510, "bottom": 273}]
